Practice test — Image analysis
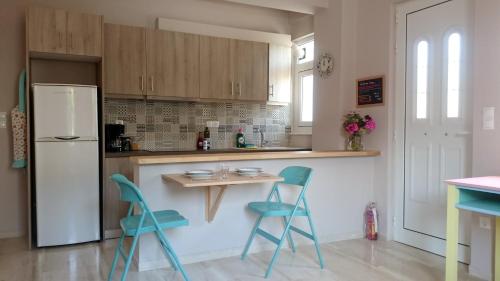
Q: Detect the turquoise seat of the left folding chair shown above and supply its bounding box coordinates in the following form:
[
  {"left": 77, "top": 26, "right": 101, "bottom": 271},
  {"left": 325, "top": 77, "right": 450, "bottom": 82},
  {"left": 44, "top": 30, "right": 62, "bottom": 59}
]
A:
[{"left": 120, "top": 210, "right": 189, "bottom": 236}]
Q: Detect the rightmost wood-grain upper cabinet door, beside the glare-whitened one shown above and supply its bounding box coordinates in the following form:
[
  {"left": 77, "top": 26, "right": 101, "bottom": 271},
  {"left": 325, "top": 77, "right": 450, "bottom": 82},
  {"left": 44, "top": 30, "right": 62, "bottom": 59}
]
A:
[{"left": 231, "top": 40, "right": 269, "bottom": 102}]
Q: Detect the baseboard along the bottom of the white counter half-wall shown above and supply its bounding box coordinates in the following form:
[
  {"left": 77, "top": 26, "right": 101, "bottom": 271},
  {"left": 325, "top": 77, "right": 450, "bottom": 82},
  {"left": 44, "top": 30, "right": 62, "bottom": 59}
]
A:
[{"left": 134, "top": 233, "right": 364, "bottom": 271}]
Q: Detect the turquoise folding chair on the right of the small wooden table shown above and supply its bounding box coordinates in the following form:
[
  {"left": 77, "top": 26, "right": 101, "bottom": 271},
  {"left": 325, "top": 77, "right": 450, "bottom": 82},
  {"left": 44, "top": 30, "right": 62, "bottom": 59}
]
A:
[{"left": 241, "top": 167, "right": 323, "bottom": 278}]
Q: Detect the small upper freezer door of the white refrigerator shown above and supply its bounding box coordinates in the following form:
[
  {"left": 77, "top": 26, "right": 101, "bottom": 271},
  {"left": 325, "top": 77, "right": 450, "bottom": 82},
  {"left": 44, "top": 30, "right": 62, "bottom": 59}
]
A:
[{"left": 33, "top": 85, "right": 98, "bottom": 141}]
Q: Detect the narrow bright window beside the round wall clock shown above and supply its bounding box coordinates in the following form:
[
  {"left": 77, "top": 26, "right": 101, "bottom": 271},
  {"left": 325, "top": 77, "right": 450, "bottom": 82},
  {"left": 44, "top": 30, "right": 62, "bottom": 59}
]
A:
[{"left": 292, "top": 36, "right": 314, "bottom": 131}]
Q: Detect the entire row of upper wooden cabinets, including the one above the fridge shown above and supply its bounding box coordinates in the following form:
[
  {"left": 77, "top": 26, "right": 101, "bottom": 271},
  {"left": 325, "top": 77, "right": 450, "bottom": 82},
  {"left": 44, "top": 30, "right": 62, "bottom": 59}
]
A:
[{"left": 27, "top": 7, "right": 291, "bottom": 102}]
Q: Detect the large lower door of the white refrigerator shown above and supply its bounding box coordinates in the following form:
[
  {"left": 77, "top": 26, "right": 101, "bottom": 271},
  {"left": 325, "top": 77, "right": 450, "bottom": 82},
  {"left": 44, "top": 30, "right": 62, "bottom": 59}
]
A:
[{"left": 35, "top": 141, "right": 100, "bottom": 247}]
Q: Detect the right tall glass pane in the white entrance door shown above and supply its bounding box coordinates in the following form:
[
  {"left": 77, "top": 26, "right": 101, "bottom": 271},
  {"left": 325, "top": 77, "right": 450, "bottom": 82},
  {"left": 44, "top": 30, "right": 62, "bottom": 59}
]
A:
[{"left": 446, "top": 33, "right": 461, "bottom": 118}]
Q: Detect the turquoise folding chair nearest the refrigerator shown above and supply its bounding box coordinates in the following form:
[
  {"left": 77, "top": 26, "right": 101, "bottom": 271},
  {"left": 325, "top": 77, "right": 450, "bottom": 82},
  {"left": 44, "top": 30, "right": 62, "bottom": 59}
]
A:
[{"left": 108, "top": 174, "right": 189, "bottom": 281}]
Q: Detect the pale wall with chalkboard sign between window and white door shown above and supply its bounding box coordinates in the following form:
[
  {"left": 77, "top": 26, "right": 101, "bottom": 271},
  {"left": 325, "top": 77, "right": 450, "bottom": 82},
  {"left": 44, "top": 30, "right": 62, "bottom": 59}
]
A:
[{"left": 312, "top": 0, "right": 394, "bottom": 237}]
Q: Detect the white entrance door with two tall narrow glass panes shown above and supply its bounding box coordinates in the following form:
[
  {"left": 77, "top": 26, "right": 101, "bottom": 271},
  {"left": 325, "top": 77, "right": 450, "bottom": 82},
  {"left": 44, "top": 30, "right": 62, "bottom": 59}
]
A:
[{"left": 396, "top": 0, "right": 472, "bottom": 262}]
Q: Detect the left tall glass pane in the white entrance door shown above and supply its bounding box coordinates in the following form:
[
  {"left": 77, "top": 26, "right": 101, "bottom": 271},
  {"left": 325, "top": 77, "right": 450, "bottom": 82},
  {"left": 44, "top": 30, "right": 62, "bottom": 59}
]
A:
[{"left": 417, "top": 41, "right": 429, "bottom": 119}]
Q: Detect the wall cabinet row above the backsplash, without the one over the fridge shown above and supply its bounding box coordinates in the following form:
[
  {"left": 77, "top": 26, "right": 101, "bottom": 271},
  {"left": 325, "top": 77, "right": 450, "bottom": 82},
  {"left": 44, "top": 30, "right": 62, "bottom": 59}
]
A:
[{"left": 104, "top": 24, "right": 291, "bottom": 102}]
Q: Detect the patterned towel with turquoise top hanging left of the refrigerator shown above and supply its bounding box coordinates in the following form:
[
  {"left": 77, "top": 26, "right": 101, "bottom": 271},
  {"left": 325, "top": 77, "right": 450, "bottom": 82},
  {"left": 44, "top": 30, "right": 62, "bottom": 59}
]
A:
[{"left": 11, "top": 70, "right": 27, "bottom": 169}]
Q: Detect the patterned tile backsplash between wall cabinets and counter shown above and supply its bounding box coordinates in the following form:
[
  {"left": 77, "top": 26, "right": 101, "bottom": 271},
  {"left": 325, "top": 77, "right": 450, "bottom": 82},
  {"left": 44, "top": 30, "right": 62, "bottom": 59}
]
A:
[{"left": 104, "top": 99, "right": 290, "bottom": 151}]
